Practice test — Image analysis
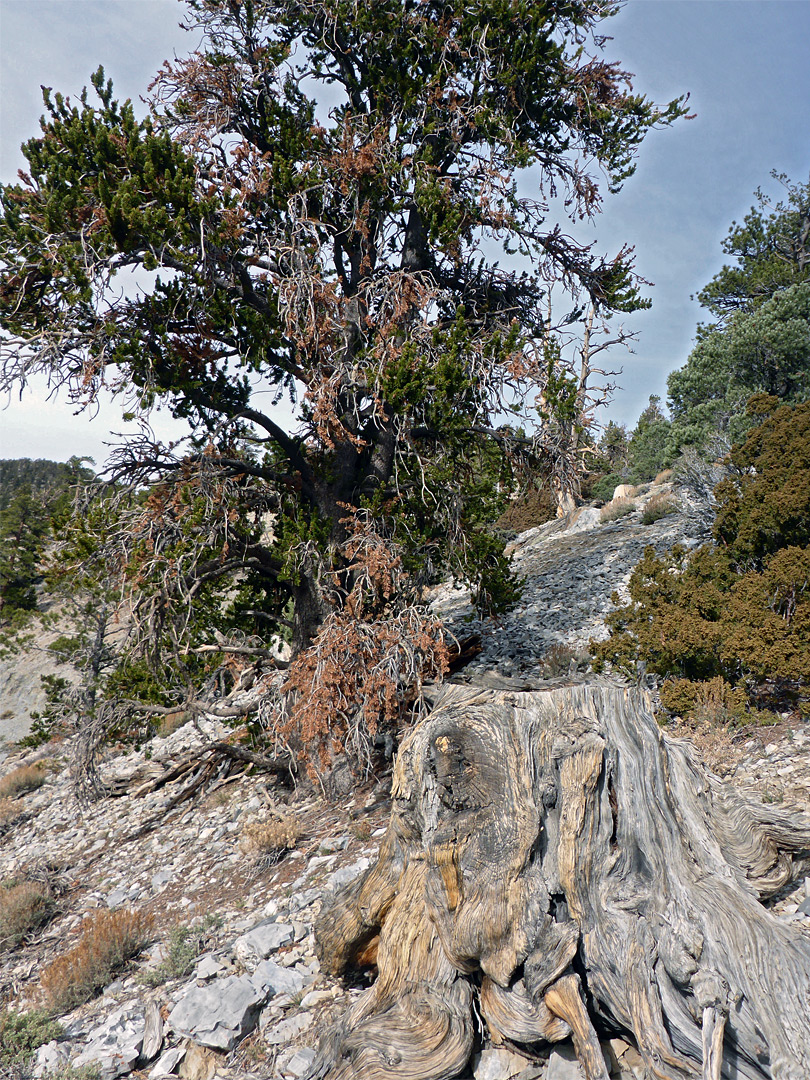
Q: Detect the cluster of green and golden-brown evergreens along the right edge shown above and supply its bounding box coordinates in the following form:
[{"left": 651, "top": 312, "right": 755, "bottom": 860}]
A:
[{"left": 594, "top": 177, "right": 810, "bottom": 725}]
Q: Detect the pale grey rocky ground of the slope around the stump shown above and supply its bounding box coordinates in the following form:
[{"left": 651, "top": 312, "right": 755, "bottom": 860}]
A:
[{"left": 0, "top": 481, "right": 810, "bottom": 1080}]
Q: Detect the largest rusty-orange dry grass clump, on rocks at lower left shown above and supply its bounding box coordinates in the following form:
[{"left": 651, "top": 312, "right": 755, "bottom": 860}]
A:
[{"left": 40, "top": 908, "right": 154, "bottom": 1014}]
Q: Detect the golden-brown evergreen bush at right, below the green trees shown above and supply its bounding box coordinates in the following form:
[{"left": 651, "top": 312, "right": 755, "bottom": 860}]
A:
[{"left": 593, "top": 397, "right": 810, "bottom": 715}]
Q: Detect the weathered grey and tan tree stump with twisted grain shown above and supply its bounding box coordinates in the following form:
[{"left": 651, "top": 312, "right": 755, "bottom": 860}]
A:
[{"left": 311, "top": 687, "right": 810, "bottom": 1080}]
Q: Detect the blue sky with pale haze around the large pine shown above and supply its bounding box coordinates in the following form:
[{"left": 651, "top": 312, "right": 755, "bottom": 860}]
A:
[{"left": 0, "top": 0, "right": 810, "bottom": 462}]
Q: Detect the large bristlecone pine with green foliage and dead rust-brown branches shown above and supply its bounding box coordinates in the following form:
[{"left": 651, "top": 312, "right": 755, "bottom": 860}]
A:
[{"left": 0, "top": 0, "right": 685, "bottom": 777}]
